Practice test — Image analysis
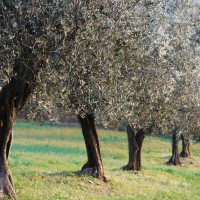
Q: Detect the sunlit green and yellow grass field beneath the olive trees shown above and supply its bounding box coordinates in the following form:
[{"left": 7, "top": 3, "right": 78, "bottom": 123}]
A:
[{"left": 9, "top": 122, "right": 200, "bottom": 200}]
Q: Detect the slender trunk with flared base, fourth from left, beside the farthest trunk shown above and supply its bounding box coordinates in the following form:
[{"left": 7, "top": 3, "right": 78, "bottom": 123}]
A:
[{"left": 167, "top": 131, "right": 181, "bottom": 166}]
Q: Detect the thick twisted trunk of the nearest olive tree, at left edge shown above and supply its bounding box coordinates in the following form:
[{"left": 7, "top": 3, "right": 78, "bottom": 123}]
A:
[{"left": 0, "top": 55, "right": 35, "bottom": 199}]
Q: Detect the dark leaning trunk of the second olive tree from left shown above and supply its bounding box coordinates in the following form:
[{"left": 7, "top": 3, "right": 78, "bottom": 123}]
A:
[{"left": 78, "top": 114, "right": 107, "bottom": 182}]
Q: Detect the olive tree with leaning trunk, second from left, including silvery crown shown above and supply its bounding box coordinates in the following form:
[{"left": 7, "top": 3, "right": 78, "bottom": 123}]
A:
[{"left": 26, "top": 1, "right": 158, "bottom": 181}]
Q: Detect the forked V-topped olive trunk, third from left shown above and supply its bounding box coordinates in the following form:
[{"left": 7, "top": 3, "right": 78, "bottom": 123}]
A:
[{"left": 122, "top": 125, "right": 145, "bottom": 171}]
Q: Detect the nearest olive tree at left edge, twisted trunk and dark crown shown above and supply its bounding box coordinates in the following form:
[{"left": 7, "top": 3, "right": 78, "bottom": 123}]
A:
[{"left": 0, "top": 0, "right": 83, "bottom": 199}]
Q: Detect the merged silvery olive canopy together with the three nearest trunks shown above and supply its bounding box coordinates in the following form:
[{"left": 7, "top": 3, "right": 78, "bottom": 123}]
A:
[{"left": 0, "top": 0, "right": 200, "bottom": 199}]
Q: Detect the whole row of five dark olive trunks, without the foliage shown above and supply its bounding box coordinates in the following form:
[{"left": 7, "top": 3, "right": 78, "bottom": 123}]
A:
[{"left": 0, "top": 86, "right": 190, "bottom": 199}]
